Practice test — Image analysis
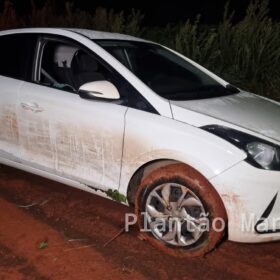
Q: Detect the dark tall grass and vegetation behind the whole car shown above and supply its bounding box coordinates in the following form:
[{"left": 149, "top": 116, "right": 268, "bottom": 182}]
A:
[{"left": 0, "top": 0, "right": 280, "bottom": 100}]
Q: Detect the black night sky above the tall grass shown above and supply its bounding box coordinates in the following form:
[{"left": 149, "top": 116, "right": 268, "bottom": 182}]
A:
[{"left": 0, "top": 0, "right": 280, "bottom": 26}]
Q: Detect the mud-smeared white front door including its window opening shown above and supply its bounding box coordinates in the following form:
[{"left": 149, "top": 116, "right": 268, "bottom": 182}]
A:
[{"left": 18, "top": 35, "right": 127, "bottom": 189}]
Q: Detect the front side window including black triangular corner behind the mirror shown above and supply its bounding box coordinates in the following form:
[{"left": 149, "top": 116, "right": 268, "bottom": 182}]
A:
[{"left": 35, "top": 38, "right": 157, "bottom": 113}]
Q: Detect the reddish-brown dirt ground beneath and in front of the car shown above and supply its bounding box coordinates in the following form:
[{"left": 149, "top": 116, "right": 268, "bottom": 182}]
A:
[{"left": 0, "top": 166, "right": 280, "bottom": 280}]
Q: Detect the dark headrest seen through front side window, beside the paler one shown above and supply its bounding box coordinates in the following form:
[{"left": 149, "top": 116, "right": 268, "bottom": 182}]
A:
[{"left": 71, "top": 50, "right": 98, "bottom": 73}]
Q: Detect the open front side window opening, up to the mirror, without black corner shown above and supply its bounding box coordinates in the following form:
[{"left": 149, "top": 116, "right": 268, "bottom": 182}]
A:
[{"left": 38, "top": 40, "right": 110, "bottom": 93}]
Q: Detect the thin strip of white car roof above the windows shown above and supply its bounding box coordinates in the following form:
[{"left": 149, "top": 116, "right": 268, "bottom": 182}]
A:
[{"left": 0, "top": 27, "right": 148, "bottom": 42}]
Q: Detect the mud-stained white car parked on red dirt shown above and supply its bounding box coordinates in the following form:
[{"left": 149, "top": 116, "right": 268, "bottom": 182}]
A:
[{"left": 0, "top": 28, "right": 280, "bottom": 256}]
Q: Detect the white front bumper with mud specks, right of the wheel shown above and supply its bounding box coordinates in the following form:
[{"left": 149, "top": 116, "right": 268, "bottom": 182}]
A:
[{"left": 210, "top": 161, "right": 280, "bottom": 242}]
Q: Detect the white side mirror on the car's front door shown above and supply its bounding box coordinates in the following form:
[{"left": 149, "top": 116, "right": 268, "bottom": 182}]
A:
[{"left": 78, "top": 81, "right": 120, "bottom": 100}]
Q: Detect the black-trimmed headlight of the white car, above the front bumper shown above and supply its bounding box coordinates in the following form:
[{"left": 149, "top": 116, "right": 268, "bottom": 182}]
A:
[{"left": 202, "top": 125, "right": 280, "bottom": 170}]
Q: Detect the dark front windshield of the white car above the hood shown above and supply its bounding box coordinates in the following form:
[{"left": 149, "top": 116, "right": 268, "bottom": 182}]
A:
[{"left": 95, "top": 40, "right": 236, "bottom": 100}]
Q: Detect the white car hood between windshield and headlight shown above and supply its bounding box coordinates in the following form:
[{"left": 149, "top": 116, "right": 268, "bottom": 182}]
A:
[{"left": 170, "top": 92, "right": 280, "bottom": 141}]
